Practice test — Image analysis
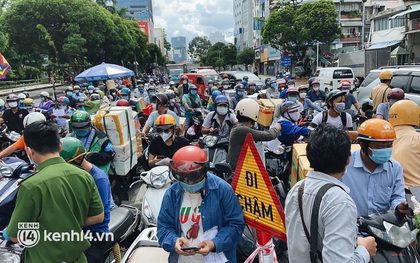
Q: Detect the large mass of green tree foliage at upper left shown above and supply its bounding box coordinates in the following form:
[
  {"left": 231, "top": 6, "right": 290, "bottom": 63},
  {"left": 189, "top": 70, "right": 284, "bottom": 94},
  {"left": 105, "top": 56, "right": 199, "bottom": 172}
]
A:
[{"left": 0, "top": 0, "right": 149, "bottom": 77}]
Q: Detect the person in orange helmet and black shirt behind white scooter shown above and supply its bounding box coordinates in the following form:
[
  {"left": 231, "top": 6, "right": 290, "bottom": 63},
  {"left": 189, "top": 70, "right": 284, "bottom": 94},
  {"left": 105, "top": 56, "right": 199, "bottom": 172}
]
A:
[{"left": 148, "top": 114, "right": 189, "bottom": 168}]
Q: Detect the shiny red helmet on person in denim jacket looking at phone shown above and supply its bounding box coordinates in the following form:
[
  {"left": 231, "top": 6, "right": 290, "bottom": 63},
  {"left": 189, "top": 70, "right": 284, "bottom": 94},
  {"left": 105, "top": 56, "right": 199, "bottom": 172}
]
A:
[{"left": 169, "top": 146, "right": 207, "bottom": 184}]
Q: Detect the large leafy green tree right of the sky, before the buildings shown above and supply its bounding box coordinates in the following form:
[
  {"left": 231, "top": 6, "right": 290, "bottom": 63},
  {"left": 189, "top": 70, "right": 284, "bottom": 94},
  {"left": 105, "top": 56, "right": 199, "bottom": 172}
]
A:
[{"left": 262, "top": 0, "right": 341, "bottom": 57}]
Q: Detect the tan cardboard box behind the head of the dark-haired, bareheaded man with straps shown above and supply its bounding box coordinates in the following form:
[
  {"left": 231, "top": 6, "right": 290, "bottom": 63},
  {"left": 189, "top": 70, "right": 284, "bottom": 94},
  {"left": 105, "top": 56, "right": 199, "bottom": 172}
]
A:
[{"left": 290, "top": 143, "right": 360, "bottom": 187}]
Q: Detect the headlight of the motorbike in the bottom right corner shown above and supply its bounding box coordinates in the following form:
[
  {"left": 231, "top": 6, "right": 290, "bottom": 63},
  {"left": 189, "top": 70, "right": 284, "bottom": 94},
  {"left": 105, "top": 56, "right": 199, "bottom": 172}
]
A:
[{"left": 369, "top": 221, "right": 416, "bottom": 248}]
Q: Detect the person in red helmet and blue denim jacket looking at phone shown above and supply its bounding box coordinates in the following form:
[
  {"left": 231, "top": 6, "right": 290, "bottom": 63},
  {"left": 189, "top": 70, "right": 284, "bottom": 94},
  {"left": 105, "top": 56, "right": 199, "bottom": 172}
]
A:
[{"left": 157, "top": 146, "right": 245, "bottom": 262}]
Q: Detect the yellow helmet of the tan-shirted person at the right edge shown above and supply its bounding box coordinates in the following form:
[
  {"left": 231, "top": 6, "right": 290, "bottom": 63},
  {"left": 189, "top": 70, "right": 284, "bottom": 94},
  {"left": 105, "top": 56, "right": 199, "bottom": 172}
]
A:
[{"left": 388, "top": 100, "right": 420, "bottom": 126}]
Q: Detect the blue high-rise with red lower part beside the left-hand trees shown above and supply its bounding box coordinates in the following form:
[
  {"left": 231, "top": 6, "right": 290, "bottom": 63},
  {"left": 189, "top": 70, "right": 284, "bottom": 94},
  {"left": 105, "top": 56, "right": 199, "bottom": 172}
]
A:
[{"left": 115, "top": 0, "right": 154, "bottom": 43}]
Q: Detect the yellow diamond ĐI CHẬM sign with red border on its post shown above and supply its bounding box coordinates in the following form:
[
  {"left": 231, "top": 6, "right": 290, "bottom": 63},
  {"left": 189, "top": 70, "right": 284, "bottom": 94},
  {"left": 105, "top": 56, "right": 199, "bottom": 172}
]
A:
[{"left": 232, "top": 134, "right": 286, "bottom": 263}]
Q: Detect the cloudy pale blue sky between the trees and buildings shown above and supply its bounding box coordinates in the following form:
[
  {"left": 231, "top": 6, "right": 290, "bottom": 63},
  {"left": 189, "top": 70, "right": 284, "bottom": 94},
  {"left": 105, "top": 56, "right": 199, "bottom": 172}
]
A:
[{"left": 153, "top": 0, "right": 234, "bottom": 45}]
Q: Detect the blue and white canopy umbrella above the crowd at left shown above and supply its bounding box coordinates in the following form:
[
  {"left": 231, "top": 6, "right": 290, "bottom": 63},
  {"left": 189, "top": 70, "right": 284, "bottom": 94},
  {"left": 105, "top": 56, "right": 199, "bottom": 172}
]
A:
[{"left": 75, "top": 62, "right": 134, "bottom": 81}]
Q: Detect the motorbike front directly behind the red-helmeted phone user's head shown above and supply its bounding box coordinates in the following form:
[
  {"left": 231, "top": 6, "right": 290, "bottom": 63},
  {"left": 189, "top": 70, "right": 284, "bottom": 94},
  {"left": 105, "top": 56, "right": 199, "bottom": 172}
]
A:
[{"left": 198, "top": 134, "right": 229, "bottom": 171}]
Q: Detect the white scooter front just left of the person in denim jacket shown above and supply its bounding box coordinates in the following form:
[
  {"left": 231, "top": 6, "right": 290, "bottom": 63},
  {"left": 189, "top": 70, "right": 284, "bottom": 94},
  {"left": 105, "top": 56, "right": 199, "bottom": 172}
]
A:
[{"left": 139, "top": 165, "right": 174, "bottom": 230}]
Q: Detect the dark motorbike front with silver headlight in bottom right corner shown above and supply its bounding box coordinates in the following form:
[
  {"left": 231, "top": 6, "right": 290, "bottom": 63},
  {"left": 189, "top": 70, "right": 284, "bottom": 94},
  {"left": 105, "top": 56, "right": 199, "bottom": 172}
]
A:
[{"left": 357, "top": 211, "right": 420, "bottom": 263}]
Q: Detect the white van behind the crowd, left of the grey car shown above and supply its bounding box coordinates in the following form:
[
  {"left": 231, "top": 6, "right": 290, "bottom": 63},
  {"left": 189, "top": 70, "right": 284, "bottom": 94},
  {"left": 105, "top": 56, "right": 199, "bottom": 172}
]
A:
[{"left": 315, "top": 67, "right": 355, "bottom": 91}]
